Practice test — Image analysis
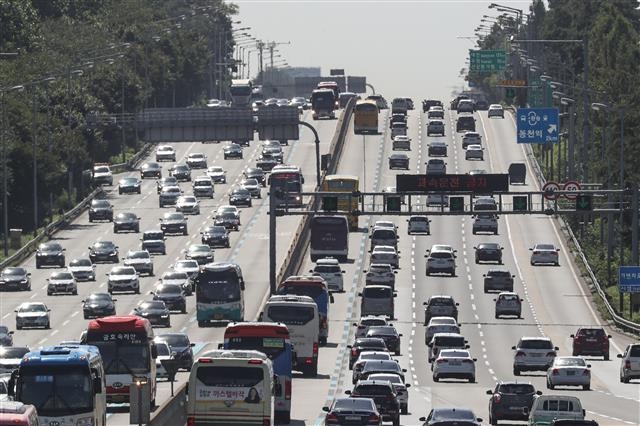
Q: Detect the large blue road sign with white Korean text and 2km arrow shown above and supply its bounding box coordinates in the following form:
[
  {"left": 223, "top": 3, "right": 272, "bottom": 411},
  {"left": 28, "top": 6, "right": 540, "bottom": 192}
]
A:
[{"left": 517, "top": 108, "right": 560, "bottom": 144}]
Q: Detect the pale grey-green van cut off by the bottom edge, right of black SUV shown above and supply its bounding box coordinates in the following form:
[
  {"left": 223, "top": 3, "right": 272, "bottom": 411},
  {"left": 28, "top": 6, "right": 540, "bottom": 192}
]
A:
[{"left": 523, "top": 395, "right": 585, "bottom": 426}]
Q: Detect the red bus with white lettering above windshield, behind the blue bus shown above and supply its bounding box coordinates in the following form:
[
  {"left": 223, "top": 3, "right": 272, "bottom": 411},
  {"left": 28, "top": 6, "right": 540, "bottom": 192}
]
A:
[{"left": 82, "top": 315, "right": 157, "bottom": 407}]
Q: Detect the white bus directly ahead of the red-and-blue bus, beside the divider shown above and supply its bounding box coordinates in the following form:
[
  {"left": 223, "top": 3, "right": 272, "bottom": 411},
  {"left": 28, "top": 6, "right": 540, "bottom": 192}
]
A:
[{"left": 260, "top": 295, "right": 320, "bottom": 377}]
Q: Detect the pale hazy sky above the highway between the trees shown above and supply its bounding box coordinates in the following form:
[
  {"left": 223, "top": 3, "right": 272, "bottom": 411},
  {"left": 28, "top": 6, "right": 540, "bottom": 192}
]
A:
[{"left": 230, "top": 0, "right": 531, "bottom": 101}]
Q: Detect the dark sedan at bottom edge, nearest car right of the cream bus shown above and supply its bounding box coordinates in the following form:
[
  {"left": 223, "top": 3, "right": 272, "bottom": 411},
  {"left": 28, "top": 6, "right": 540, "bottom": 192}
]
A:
[{"left": 322, "top": 398, "right": 382, "bottom": 426}]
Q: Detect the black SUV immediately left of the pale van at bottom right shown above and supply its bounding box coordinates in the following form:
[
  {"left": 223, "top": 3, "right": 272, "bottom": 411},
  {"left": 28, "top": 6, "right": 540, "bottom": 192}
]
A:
[{"left": 487, "top": 382, "right": 542, "bottom": 425}]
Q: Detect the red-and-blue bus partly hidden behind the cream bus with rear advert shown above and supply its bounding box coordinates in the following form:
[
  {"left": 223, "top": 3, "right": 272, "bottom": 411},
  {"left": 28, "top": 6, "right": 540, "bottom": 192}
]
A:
[{"left": 222, "top": 322, "right": 293, "bottom": 424}]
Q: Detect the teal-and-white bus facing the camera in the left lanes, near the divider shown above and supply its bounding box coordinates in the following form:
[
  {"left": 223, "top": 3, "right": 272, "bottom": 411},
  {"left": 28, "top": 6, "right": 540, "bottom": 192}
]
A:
[{"left": 194, "top": 262, "right": 244, "bottom": 327}]
